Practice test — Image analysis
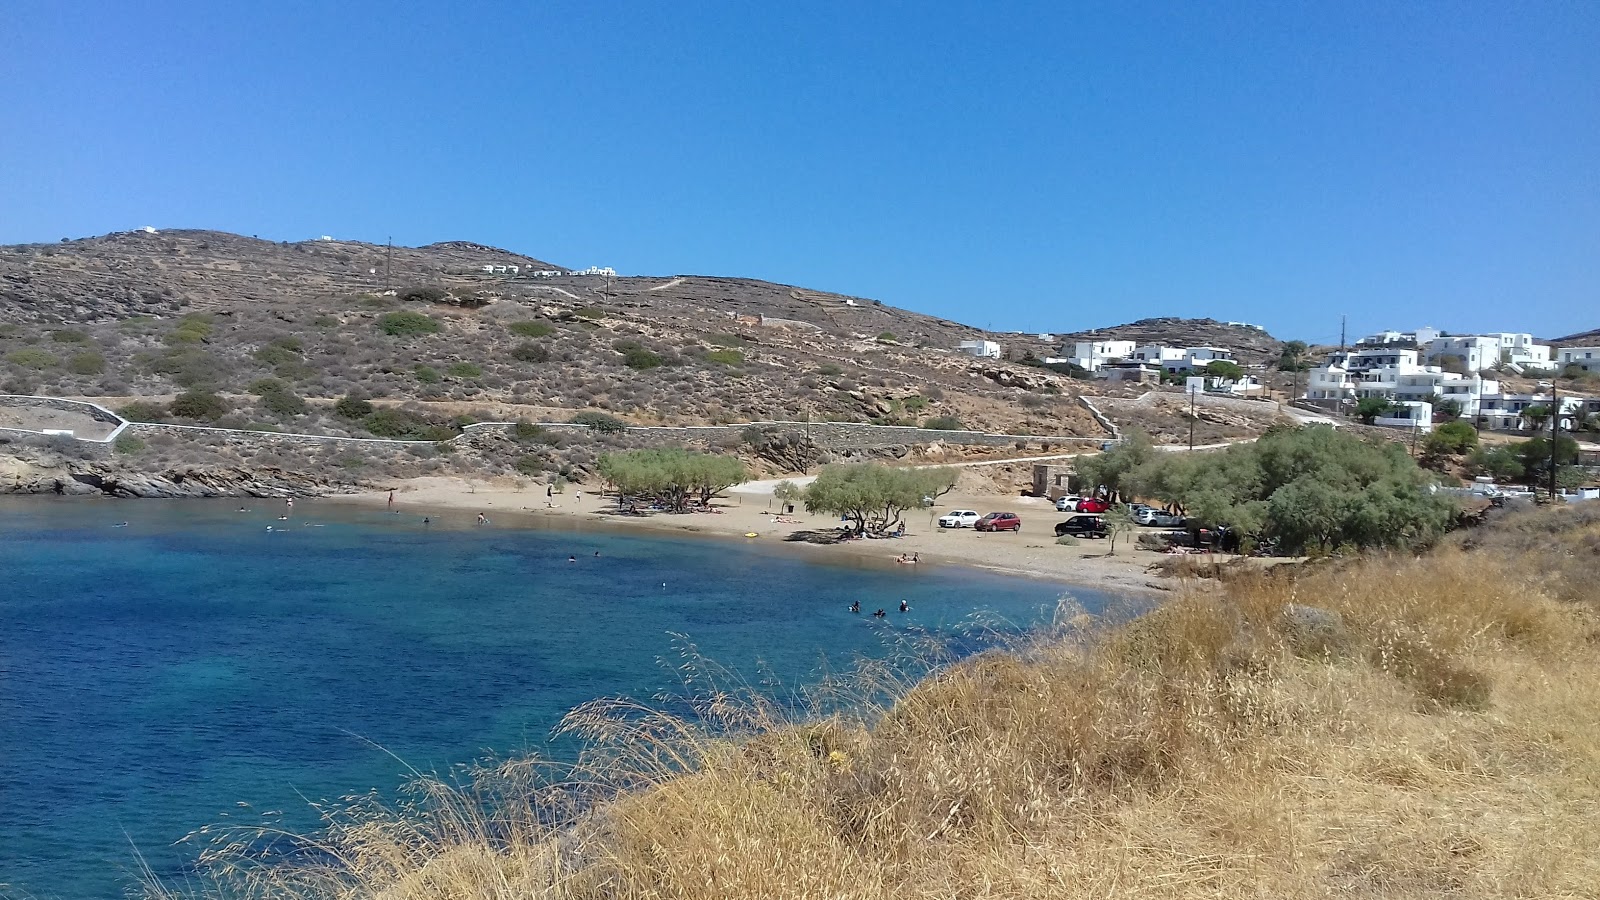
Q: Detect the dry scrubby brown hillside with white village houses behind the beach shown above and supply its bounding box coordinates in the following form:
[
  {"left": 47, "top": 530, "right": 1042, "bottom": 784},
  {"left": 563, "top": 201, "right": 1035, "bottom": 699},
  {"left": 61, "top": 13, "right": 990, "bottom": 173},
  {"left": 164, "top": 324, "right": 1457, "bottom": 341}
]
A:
[{"left": 0, "top": 229, "right": 1600, "bottom": 499}]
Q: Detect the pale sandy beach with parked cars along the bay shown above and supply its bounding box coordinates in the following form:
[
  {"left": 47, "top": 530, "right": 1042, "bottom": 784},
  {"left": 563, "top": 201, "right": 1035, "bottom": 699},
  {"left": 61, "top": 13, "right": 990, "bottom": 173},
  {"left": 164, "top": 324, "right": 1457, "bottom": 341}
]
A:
[{"left": 326, "top": 477, "right": 1176, "bottom": 594}]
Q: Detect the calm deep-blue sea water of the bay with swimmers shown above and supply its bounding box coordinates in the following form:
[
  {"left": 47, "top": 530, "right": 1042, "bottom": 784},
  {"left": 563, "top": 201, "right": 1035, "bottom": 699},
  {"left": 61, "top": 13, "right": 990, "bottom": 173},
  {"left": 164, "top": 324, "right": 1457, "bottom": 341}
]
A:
[{"left": 0, "top": 498, "right": 1106, "bottom": 898}]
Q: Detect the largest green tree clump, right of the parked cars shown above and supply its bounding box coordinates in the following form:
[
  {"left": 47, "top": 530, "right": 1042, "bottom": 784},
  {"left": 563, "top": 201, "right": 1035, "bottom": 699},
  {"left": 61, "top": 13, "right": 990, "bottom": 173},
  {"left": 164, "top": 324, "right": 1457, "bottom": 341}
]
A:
[{"left": 1078, "top": 426, "right": 1454, "bottom": 552}]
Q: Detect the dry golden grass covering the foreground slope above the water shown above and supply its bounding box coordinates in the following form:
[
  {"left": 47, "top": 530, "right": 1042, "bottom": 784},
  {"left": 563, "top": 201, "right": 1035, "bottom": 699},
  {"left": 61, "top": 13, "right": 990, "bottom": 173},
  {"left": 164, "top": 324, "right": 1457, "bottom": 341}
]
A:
[{"left": 152, "top": 514, "right": 1600, "bottom": 900}]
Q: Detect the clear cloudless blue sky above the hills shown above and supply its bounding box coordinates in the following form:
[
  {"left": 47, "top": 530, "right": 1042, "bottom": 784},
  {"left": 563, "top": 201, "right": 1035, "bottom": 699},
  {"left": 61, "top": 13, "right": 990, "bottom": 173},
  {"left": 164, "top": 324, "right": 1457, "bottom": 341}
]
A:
[{"left": 0, "top": 0, "right": 1600, "bottom": 341}]
